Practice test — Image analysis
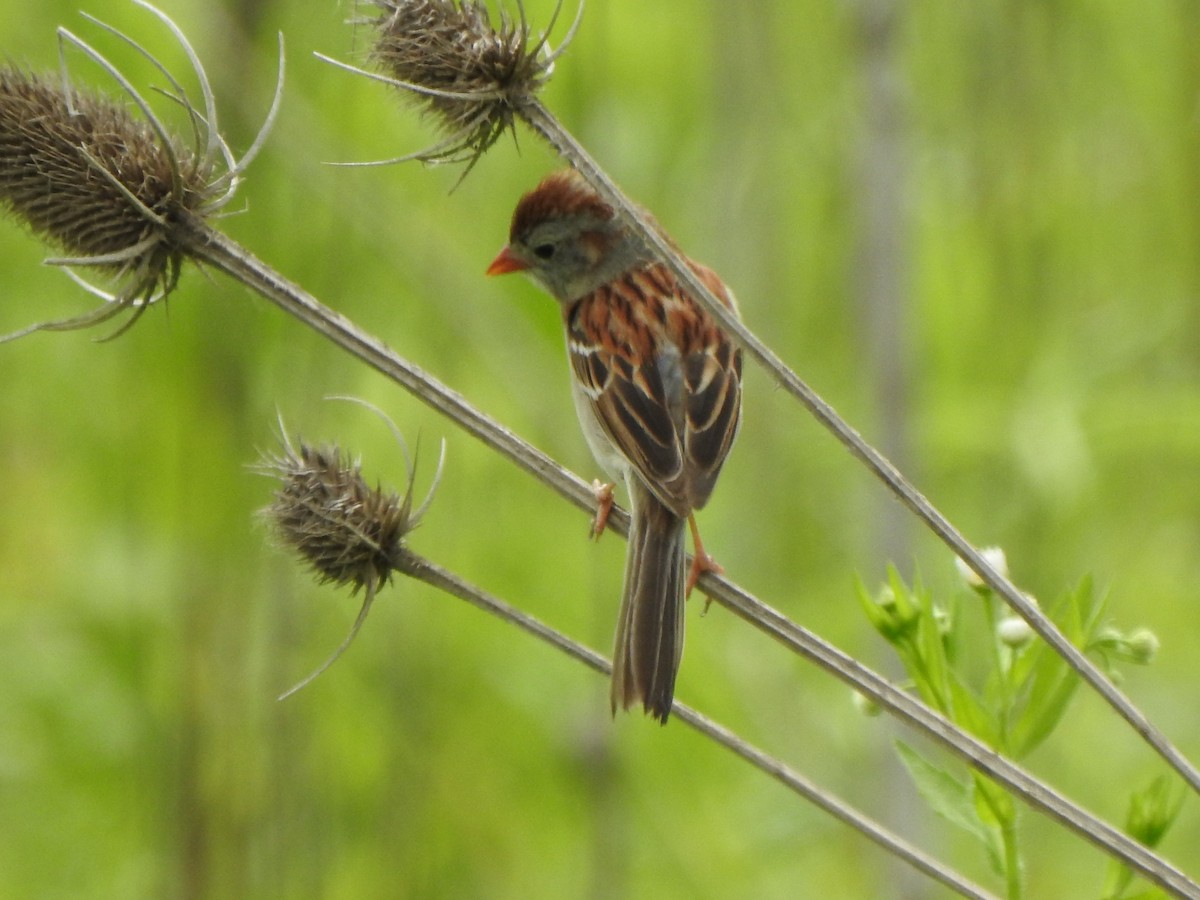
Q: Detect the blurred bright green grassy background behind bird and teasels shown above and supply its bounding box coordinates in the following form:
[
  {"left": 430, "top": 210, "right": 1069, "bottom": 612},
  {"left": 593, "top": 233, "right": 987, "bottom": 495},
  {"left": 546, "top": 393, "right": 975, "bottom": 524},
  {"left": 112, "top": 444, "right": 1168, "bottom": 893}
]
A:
[{"left": 0, "top": 0, "right": 1200, "bottom": 898}]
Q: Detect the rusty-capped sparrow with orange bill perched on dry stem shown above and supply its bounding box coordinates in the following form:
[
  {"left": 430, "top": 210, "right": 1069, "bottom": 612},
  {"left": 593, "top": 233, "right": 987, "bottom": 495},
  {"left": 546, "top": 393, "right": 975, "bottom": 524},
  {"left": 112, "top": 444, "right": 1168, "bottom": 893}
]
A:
[{"left": 487, "top": 169, "right": 742, "bottom": 724}]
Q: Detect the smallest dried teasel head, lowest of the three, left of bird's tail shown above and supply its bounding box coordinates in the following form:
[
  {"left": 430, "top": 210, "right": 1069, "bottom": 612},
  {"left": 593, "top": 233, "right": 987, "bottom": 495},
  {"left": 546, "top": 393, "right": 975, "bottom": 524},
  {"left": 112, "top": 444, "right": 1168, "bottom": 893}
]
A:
[{"left": 256, "top": 414, "right": 445, "bottom": 700}]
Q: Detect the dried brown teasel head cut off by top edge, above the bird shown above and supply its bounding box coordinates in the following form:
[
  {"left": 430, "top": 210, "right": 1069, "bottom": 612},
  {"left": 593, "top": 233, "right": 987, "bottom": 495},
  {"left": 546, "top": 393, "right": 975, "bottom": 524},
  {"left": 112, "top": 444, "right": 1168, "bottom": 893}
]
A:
[{"left": 325, "top": 0, "right": 583, "bottom": 176}]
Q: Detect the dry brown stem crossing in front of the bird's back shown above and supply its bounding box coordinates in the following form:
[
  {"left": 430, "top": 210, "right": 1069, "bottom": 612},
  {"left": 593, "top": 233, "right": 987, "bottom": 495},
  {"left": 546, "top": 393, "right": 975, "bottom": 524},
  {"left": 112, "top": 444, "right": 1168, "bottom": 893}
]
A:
[{"left": 516, "top": 97, "right": 1200, "bottom": 793}]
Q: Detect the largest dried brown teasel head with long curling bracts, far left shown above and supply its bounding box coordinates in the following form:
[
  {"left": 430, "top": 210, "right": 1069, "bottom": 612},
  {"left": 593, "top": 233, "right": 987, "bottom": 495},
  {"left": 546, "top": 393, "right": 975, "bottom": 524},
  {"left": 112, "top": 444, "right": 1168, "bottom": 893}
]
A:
[{"left": 0, "top": 0, "right": 283, "bottom": 342}]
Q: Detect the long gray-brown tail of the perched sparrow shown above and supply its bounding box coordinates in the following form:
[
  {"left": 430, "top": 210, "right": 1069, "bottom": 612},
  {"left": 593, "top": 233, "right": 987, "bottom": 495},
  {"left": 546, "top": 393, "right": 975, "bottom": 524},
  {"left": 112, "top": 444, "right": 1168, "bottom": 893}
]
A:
[{"left": 612, "top": 478, "right": 688, "bottom": 724}]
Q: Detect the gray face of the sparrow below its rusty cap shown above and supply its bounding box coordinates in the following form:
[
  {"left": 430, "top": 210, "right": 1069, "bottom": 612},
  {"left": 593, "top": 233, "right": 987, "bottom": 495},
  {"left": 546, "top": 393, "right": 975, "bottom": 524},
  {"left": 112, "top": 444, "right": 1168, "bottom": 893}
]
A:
[{"left": 512, "top": 215, "right": 640, "bottom": 302}]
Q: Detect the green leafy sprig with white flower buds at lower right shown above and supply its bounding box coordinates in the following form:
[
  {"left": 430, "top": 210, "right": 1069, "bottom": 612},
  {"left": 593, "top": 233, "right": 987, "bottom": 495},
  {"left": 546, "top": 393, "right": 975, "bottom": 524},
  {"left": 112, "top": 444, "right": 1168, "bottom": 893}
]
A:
[{"left": 858, "top": 548, "right": 1180, "bottom": 900}]
